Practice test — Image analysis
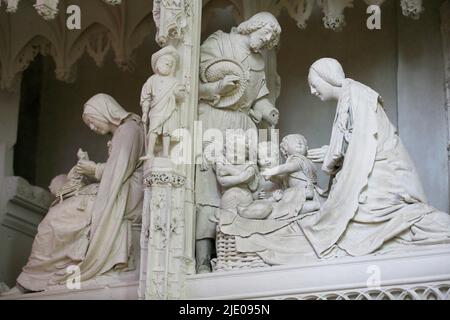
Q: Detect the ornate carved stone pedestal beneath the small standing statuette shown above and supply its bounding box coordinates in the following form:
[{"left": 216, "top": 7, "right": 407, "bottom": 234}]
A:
[{"left": 139, "top": 158, "right": 187, "bottom": 300}]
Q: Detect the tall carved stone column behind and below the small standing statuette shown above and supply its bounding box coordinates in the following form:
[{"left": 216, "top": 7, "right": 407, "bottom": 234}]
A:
[{"left": 139, "top": 0, "right": 202, "bottom": 300}]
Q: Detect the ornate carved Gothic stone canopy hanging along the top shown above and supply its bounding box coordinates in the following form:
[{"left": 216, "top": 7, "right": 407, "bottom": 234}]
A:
[{"left": 0, "top": 0, "right": 424, "bottom": 90}]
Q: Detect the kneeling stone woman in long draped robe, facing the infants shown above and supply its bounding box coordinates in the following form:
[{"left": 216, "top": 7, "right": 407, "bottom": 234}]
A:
[{"left": 301, "top": 58, "right": 450, "bottom": 258}]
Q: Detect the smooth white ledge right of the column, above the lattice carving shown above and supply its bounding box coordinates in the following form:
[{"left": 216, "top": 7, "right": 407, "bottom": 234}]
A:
[{"left": 187, "top": 249, "right": 450, "bottom": 299}]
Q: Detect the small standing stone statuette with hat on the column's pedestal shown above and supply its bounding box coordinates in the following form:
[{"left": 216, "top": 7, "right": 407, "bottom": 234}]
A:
[{"left": 141, "top": 46, "right": 186, "bottom": 160}]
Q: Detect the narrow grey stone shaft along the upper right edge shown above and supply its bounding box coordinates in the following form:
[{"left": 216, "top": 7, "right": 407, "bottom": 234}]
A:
[{"left": 441, "top": 1, "right": 450, "bottom": 208}]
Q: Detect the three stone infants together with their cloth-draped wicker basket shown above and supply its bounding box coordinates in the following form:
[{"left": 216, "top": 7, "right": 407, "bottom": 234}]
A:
[{"left": 213, "top": 135, "right": 320, "bottom": 271}]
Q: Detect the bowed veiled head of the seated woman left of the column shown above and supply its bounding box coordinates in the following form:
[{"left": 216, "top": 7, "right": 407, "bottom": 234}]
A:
[{"left": 83, "top": 93, "right": 130, "bottom": 135}]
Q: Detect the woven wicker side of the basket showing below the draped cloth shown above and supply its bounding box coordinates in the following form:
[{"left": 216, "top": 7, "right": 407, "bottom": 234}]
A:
[{"left": 212, "top": 227, "right": 269, "bottom": 272}]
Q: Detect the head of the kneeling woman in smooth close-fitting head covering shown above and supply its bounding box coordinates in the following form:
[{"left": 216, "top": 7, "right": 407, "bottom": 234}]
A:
[{"left": 308, "top": 58, "right": 345, "bottom": 101}]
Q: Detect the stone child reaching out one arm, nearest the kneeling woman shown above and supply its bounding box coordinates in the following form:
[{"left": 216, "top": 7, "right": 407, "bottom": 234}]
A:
[{"left": 261, "top": 134, "right": 320, "bottom": 213}]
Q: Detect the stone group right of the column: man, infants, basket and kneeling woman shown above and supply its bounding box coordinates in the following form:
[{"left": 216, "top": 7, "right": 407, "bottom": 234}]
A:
[{"left": 196, "top": 12, "right": 450, "bottom": 273}]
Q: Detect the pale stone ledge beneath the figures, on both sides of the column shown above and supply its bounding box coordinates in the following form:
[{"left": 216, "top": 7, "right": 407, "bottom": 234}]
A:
[{"left": 5, "top": 248, "right": 450, "bottom": 300}]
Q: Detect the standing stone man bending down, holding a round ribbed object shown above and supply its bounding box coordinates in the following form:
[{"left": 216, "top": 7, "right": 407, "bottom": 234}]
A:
[{"left": 195, "top": 12, "right": 281, "bottom": 272}]
